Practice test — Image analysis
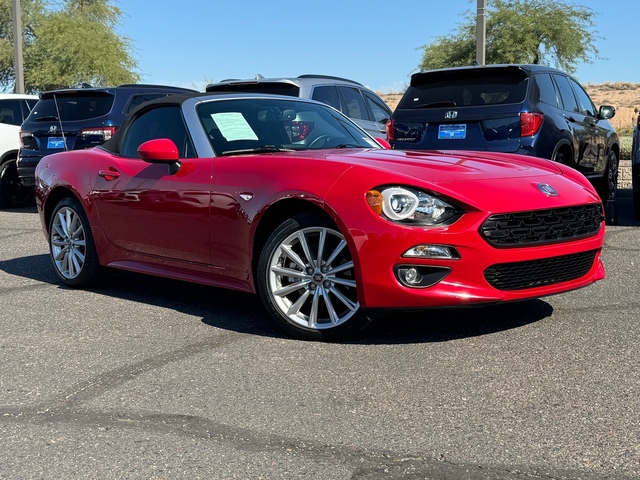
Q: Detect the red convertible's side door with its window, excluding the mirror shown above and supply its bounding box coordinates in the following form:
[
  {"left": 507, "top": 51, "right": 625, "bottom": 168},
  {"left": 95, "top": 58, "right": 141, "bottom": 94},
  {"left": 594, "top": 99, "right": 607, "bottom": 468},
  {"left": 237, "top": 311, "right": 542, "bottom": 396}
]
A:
[{"left": 92, "top": 105, "right": 212, "bottom": 264}]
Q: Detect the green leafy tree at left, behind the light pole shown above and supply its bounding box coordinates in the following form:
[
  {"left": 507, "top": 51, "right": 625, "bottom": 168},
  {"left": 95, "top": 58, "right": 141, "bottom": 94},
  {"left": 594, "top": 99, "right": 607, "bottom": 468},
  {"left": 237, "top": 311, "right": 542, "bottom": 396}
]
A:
[{"left": 0, "top": 0, "right": 140, "bottom": 93}]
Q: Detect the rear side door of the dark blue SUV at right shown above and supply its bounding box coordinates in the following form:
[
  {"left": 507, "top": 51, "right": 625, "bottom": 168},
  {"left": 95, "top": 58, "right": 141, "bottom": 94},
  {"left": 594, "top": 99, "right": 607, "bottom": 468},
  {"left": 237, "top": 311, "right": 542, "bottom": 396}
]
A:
[{"left": 553, "top": 75, "right": 598, "bottom": 174}]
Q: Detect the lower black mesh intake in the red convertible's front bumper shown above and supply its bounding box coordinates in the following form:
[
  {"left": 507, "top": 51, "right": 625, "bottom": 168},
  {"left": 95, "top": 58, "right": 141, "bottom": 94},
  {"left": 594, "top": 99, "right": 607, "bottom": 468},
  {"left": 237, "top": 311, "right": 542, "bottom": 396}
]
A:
[{"left": 484, "top": 250, "right": 597, "bottom": 290}]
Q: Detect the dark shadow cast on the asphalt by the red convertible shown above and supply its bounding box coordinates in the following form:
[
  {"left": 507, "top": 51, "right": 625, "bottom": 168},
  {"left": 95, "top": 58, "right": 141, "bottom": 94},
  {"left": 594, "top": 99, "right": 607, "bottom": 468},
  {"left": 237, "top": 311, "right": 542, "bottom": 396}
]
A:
[{"left": 0, "top": 254, "right": 553, "bottom": 344}]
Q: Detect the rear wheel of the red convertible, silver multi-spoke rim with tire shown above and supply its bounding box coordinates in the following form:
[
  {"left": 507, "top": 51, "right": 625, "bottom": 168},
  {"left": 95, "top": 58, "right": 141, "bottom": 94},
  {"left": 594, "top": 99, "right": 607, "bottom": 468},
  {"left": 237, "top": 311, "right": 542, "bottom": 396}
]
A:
[{"left": 49, "top": 198, "right": 105, "bottom": 287}]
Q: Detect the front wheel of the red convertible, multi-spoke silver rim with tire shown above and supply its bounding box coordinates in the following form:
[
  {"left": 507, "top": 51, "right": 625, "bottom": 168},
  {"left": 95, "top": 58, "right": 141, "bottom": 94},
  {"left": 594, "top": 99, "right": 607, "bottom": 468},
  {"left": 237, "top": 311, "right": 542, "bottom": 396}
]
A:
[{"left": 257, "top": 214, "right": 369, "bottom": 340}]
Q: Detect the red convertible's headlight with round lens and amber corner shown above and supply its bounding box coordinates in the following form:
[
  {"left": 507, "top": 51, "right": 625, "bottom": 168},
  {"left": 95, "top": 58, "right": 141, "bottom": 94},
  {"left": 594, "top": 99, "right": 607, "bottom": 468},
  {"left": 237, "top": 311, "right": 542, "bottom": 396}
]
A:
[{"left": 367, "top": 186, "right": 459, "bottom": 225}]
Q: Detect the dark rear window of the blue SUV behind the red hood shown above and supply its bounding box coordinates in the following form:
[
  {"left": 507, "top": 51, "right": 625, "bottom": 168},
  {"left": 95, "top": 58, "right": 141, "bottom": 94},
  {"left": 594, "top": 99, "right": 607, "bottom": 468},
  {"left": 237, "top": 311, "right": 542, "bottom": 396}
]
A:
[{"left": 398, "top": 70, "right": 529, "bottom": 109}]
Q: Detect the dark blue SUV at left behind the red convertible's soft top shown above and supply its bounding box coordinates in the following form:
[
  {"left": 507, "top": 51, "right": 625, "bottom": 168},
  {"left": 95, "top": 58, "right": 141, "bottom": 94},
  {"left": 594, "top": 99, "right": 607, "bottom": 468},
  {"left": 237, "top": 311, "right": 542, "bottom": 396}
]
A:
[{"left": 17, "top": 84, "right": 196, "bottom": 197}]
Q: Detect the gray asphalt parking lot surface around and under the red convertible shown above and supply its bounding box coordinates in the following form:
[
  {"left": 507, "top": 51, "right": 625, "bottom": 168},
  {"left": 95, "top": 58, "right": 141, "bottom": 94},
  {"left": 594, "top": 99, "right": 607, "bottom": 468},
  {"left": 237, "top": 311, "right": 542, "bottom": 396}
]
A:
[{"left": 0, "top": 190, "right": 640, "bottom": 480}]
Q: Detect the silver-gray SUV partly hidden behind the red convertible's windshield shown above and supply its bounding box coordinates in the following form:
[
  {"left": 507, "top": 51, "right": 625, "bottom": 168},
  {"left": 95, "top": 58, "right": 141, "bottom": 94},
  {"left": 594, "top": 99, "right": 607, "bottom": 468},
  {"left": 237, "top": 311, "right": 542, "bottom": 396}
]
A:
[{"left": 206, "top": 75, "right": 391, "bottom": 138}]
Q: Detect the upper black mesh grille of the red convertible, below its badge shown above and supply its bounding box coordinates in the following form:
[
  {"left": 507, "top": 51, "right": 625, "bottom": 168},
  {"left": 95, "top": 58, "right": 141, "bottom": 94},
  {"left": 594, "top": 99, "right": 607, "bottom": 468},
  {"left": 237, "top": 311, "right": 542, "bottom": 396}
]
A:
[{"left": 480, "top": 203, "right": 604, "bottom": 247}]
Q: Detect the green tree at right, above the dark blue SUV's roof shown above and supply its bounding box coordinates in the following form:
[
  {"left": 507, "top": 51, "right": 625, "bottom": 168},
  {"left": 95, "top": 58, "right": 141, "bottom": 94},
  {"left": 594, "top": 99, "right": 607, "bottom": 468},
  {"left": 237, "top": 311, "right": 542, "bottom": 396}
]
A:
[{"left": 419, "top": 0, "right": 599, "bottom": 73}]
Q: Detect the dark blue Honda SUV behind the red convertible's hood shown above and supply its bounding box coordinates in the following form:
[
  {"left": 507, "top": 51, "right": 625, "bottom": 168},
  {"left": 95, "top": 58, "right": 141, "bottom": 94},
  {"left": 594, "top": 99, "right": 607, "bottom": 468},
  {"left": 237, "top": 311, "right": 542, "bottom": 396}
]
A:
[{"left": 387, "top": 65, "right": 620, "bottom": 215}]
